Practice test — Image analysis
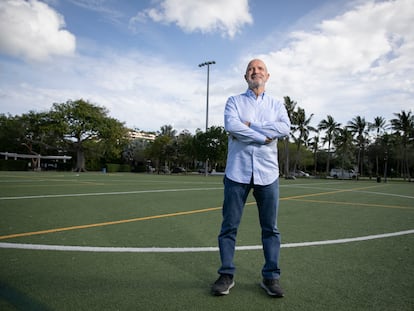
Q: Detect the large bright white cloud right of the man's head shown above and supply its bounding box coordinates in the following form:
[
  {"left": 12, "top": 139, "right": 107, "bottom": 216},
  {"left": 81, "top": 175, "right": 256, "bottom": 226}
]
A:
[{"left": 262, "top": 0, "right": 414, "bottom": 127}]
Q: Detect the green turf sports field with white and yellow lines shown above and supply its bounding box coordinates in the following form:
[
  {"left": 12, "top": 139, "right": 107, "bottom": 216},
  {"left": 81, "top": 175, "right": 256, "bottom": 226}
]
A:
[{"left": 0, "top": 172, "right": 414, "bottom": 311}]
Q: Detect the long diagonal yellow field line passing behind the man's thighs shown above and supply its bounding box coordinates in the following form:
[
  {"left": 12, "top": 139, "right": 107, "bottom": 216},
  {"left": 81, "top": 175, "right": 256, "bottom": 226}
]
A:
[{"left": 0, "top": 186, "right": 398, "bottom": 240}]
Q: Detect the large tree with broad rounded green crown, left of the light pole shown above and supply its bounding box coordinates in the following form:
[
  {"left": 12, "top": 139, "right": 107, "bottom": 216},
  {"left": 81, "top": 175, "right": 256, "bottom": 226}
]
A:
[{"left": 50, "top": 99, "right": 127, "bottom": 171}]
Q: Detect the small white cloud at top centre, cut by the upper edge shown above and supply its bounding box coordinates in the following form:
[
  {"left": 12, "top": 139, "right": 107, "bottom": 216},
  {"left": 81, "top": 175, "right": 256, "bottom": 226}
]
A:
[{"left": 133, "top": 0, "right": 253, "bottom": 38}]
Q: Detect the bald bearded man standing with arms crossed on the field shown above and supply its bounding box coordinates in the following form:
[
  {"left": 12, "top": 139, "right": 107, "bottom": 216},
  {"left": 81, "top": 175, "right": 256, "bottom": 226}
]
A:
[{"left": 212, "top": 59, "right": 290, "bottom": 297}]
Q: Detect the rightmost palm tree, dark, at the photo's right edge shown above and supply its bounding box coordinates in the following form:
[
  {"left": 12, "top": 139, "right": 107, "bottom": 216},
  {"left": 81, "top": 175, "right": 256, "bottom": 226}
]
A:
[{"left": 391, "top": 110, "right": 414, "bottom": 180}]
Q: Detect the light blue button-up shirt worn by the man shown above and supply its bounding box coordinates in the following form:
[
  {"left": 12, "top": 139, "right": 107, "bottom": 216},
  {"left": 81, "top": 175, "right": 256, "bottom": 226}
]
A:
[{"left": 224, "top": 89, "right": 290, "bottom": 185}]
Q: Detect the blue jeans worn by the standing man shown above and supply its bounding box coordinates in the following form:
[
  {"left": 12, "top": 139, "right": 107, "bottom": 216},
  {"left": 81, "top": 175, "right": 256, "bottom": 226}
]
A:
[{"left": 218, "top": 177, "right": 281, "bottom": 279}]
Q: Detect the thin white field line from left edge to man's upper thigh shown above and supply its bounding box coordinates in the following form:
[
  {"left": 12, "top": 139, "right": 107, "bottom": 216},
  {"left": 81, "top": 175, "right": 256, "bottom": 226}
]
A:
[{"left": 0, "top": 187, "right": 223, "bottom": 200}]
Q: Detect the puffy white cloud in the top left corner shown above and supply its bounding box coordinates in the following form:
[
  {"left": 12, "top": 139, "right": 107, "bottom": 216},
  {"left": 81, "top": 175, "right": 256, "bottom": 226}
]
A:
[{"left": 0, "top": 0, "right": 76, "bottom": 61}]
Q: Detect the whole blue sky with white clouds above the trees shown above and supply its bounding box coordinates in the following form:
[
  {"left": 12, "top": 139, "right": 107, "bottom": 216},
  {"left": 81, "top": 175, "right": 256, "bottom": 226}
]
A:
[{"left": 0, "top": 0, "right": 414, "bottom": 133}]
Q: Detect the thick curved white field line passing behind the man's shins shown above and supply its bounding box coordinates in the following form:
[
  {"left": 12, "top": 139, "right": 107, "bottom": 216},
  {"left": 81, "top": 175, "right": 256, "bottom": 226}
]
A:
[{"left": 0, "top": 229, "right": 414, "bottom": 253}]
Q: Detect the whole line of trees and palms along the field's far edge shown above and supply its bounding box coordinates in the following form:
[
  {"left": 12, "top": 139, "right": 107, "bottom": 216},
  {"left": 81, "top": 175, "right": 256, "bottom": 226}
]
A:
[{"left": 0, "top": 96, "right": 414, "bottom": 179}]
